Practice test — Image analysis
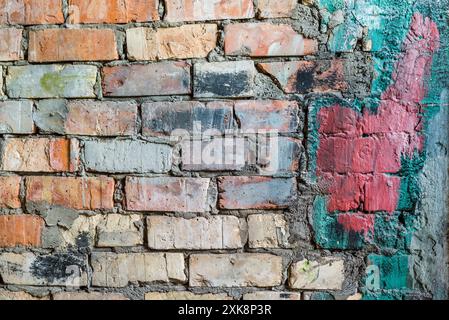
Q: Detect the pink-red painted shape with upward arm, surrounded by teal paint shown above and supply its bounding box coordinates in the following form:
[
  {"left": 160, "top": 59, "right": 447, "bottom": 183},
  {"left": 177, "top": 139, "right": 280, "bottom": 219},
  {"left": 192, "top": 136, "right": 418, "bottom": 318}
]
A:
[{"left": 317, "top": 14, "right": 439, "bottom": 218}]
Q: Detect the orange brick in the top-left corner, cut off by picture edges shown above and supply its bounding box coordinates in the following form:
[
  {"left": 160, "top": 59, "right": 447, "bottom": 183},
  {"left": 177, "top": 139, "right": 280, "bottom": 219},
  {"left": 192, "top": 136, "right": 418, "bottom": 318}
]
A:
[{"left": 0, "top": 0, "right": 64, "bottom": 25}]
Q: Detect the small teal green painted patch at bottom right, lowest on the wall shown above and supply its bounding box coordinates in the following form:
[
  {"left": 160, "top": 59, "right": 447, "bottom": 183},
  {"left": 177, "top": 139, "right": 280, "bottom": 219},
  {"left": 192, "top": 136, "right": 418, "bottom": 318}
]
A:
[{"left": 368, "top": 254, "right": 411, "bottom": 290}]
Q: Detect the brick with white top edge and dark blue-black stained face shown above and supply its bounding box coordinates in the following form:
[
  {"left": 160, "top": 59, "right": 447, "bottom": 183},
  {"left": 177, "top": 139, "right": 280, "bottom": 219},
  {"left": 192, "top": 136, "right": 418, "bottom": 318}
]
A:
[{"left": 194, "top": 61, "right": 256, "bottom": 98}]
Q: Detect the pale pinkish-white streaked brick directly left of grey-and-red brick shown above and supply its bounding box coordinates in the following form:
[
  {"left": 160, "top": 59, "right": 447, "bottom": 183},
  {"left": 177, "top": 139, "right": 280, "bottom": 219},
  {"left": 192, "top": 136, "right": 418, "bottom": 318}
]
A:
[{"left": 125, "top": 177, "right": 210, "bottom": 212}]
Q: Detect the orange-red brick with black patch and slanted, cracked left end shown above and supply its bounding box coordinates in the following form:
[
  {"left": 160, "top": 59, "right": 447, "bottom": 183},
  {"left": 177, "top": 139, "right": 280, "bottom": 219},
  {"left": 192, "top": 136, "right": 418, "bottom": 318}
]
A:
[{"left": 258, "top": 59, "right": 348, "bottom": 93}]
